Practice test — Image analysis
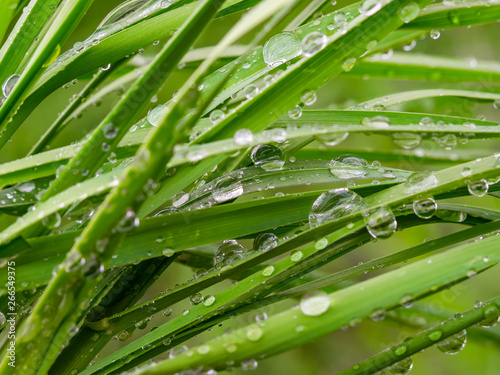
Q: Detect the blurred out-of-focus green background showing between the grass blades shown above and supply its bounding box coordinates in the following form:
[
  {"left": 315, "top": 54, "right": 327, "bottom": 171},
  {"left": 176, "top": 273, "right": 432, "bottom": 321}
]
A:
[{"left": 0, "top": 0, "right": 500, "bottom": 375}]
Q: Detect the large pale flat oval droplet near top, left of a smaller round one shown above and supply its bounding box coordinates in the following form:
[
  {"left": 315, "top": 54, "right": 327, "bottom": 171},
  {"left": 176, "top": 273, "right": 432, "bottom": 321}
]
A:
[{"left": 262, "top": 31, "right": 302, "bottom": 67}]
